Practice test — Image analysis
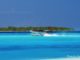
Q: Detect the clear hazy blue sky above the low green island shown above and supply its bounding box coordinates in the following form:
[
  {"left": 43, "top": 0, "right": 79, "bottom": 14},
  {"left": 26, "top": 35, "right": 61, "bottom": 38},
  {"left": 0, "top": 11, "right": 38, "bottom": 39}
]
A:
[{"left": 0, "top": 0, "right": 80, "bottom": 30}]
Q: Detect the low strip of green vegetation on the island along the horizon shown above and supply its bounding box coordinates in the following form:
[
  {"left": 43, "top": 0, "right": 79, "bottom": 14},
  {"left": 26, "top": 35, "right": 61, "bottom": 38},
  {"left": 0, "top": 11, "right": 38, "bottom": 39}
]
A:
[{"left": 0, "top": 26, "right": 73, "bottom": 32}]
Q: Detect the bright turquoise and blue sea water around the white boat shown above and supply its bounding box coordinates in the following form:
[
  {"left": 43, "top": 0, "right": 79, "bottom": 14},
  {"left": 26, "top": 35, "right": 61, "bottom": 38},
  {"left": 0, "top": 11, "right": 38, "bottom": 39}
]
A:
[{"left": 0, "top": 32, "right": 80, "bottom": 60}]
